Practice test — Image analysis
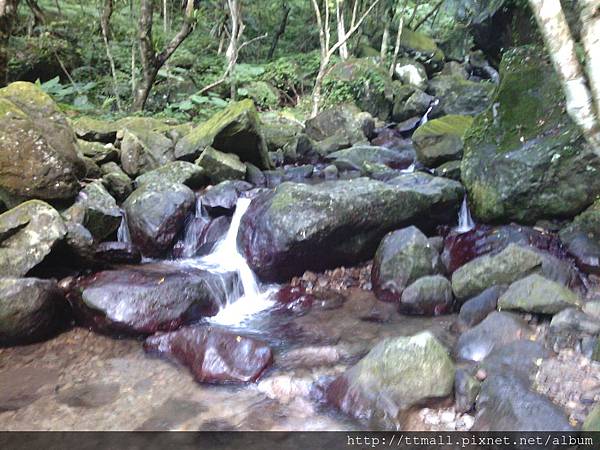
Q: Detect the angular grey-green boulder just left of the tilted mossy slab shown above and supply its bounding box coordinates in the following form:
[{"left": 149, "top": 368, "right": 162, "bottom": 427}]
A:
[{"left": 121, "top": 128, "right": 175, "bottom": 177}]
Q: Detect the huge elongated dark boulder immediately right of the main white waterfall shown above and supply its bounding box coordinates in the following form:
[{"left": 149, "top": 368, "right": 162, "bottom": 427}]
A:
[{"left": 238, "top": 173, "right": 463, "bottom": 280}]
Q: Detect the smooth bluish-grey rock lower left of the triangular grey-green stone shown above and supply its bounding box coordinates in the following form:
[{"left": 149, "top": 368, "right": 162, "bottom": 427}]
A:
[{"left": 456, "top": 312, "right": 532, "bottom": 361}]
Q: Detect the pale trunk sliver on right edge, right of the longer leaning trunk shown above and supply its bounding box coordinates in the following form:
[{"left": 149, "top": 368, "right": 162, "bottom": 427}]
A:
[{"left": 581, "top": 0, "right": 600, "bottom": 122}]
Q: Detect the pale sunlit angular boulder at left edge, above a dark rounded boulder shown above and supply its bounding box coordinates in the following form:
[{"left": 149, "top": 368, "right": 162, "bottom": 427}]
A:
[{"left": 0, "top": 200, "right": 67, "bottom": 277}]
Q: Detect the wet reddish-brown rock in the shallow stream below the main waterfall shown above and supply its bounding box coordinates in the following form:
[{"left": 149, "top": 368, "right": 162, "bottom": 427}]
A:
[{"left": 144, "top": 326, "right": 273, "bottom": 384}]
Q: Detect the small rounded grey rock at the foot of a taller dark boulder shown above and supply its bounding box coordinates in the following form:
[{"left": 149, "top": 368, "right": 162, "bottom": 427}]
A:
[{"left": 398, "top": 275, "right": 454, "bottom": 316}]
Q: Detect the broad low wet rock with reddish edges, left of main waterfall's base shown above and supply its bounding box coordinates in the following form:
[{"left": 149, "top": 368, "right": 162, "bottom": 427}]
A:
[{"left": 67, "top": 264, "right": 236, "bottom": 336}]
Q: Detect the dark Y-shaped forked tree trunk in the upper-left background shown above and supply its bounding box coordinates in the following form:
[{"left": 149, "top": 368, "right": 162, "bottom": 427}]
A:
[{"left": 133, "top": 0, "right": 194, "bottom": 111}]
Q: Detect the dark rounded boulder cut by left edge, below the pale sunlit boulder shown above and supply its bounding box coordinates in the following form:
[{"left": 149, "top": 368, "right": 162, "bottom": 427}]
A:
[{"left": 0, "top": 278, "right": 64, "bottom": 346}]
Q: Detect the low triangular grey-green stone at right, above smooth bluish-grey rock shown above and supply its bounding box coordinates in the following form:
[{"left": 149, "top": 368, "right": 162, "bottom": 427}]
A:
[{"left": 498, "top": 274, "right": 581, "bottom": 315}]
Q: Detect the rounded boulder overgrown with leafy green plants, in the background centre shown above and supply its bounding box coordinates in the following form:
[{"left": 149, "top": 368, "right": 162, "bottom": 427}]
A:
[{"left": 323, "top": 58, "right": 394, "bottom": 120}]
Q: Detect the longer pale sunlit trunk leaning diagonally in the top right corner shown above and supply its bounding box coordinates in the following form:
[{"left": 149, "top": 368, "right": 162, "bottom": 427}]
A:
[{"left": 529, "top": 0, "right": 600, "bottom": 152}]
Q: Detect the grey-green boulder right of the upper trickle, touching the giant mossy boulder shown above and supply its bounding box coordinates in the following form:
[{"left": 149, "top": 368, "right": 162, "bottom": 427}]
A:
[{"left": 427, "top": 75, "right": 496, "bottom": 116}]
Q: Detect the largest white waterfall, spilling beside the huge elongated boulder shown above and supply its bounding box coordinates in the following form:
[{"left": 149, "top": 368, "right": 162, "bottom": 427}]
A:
[{"left": 188, "top": 198, "right": 274, "bottom": 325}]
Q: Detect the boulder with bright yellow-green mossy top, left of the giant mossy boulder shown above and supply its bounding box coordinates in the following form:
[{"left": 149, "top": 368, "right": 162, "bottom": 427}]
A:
[{"left": 413, "top": 115, "right": 473, "bottom": 167}]
